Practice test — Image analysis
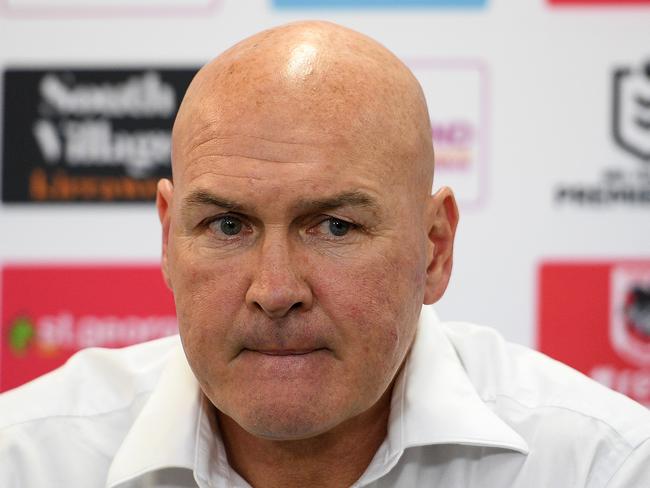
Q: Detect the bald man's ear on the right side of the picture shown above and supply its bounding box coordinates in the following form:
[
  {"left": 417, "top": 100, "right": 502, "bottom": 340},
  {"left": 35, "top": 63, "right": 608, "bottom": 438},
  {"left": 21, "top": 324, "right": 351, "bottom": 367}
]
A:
[{"left": 424, "top": 187, "right": 458, "bottom": 305}]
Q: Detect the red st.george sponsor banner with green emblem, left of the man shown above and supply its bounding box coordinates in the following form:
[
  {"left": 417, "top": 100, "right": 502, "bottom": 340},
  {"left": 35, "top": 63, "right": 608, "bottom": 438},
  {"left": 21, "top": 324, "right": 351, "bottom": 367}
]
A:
[{"left": 0, "top": 265, "right": 177, "bottom": 391}]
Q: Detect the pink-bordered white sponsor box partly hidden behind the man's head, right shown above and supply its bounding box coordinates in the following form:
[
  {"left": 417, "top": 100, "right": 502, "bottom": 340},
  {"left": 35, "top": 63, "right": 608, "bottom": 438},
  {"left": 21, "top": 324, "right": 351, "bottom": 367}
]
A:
[{"left": 407, "top": 59, "right": 488, "bottom": 207}]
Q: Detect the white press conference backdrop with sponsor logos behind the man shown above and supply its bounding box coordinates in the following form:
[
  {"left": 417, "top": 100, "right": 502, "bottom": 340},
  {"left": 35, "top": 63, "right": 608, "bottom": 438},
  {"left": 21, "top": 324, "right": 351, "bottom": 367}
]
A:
[{"left": 0, "top": 0, "right": 650, "bottom": 404}]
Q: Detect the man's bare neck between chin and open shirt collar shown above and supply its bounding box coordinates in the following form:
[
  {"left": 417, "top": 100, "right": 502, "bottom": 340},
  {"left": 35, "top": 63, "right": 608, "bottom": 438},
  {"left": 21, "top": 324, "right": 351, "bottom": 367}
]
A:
[{"left": 217, "top": 388, "right": 391, "bottom": 488}]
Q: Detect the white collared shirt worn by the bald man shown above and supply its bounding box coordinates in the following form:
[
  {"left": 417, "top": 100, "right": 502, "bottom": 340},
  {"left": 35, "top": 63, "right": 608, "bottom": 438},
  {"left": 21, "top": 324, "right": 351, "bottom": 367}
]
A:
[{"left": 0, "top": 307, "right": 650, "bottom": 488}]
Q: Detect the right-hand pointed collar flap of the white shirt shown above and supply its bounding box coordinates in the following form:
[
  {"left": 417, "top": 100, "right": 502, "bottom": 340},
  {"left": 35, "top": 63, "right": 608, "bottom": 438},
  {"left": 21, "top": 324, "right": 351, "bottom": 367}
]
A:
[{"left": 387, "top": 306, "right": 528, "bottom": 454}]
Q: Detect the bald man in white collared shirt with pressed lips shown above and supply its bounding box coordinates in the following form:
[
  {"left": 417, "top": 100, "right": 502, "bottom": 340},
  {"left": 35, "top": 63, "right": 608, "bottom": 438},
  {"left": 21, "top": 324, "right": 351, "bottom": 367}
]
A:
[{"left": 0, "top": 22, "right": 650, "bottom": 488}]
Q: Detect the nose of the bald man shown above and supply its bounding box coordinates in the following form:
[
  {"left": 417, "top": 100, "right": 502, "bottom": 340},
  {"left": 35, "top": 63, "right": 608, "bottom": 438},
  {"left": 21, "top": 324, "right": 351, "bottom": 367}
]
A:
[{"left": 246, "top": 233, "right": 313, "bottom": 319}]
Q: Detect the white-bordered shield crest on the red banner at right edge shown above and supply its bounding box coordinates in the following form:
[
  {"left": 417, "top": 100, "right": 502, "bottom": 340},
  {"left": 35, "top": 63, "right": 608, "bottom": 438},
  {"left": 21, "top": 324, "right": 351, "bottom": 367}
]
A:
[{"left": 609, "top": 266, "right": 650, "bottom": 366}]
